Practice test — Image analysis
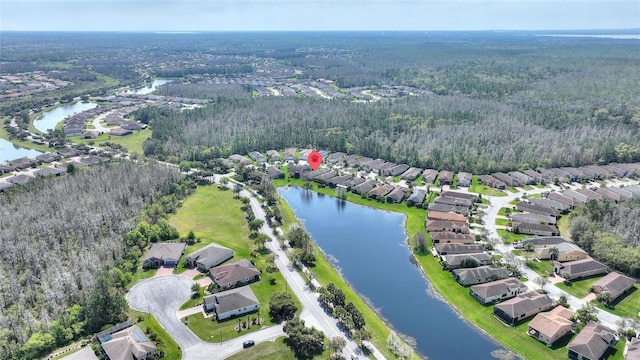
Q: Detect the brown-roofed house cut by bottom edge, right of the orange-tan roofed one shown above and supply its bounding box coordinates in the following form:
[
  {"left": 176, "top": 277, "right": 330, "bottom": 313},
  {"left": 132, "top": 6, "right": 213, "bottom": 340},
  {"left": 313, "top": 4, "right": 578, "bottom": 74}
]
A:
[{"left": 567, "top": 321, "right": 617, "bottom": 360}]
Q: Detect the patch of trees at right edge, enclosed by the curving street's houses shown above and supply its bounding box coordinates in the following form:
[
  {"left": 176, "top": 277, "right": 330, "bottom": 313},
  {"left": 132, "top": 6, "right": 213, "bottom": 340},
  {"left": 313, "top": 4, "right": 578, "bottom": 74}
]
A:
[{"left": 569, "top": 200, "right": 640, "bottom": 278}]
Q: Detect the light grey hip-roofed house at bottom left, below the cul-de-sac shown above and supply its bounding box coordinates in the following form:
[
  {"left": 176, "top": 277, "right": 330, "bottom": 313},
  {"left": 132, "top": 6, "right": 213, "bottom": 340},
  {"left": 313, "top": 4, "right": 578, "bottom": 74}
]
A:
[{"left": 98, "top": 325, "right": 156, "bottom": 360}]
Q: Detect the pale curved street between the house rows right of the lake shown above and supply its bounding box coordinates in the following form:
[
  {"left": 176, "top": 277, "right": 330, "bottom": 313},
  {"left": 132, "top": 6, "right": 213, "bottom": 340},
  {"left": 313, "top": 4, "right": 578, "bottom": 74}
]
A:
[{"left": 483, "top": 180, "right": 638, "bottom": 329}]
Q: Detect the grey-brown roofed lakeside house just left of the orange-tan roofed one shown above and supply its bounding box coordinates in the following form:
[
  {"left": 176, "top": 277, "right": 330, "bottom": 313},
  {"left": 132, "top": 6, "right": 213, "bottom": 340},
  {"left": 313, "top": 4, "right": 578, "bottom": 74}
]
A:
[{"left": 493, "top": 291, "right": 553, "bottom": 326}]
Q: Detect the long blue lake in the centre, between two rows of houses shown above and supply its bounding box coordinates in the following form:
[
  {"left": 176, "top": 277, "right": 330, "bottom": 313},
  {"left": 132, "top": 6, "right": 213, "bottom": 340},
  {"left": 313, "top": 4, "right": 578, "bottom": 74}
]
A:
[{"left": 278, "top": 187, "right": 503, "bottom": 359}]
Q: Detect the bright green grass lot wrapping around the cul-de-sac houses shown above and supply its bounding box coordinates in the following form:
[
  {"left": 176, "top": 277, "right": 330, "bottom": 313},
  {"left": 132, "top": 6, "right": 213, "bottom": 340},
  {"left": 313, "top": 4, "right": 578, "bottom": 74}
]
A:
[{"left": 169, "top": 185, "right": 301, "bottom": 341}]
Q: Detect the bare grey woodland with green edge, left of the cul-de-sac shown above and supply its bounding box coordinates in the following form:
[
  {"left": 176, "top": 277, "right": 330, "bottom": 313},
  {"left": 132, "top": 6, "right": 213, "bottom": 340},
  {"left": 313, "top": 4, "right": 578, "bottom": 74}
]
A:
[{"left": 0, "top": 161, "right": 185, "bottom": 359}]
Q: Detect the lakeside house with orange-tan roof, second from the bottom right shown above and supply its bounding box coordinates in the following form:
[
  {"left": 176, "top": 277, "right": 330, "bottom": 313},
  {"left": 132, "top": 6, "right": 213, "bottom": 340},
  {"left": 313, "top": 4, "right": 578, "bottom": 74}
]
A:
[{"left": 527, "top": 306, "right": 573, "bottom": 346}]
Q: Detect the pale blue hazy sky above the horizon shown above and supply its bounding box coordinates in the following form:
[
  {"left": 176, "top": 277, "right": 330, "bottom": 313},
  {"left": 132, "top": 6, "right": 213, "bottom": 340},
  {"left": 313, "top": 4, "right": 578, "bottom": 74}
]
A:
[{"left": 0, "top": 0, "right": 640, "bottom": 31}]
